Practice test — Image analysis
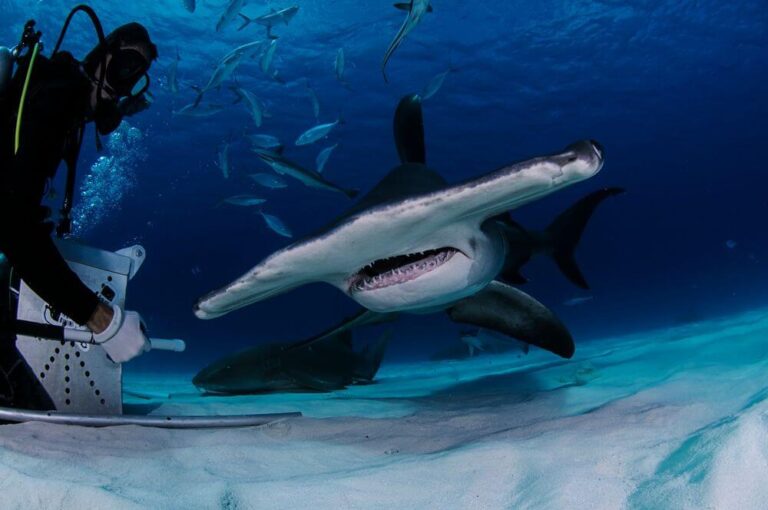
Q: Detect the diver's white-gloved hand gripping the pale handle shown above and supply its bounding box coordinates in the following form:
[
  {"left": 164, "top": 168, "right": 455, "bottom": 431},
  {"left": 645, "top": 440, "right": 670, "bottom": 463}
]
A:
[{"left": 93, "top": 306, "right": 151, "bottom": 363}]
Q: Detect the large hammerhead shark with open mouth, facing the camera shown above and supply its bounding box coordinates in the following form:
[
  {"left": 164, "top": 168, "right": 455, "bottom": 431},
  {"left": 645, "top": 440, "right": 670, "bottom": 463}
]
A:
[{"left": 194, "top": 95, "right": 623, "bottom": 357}]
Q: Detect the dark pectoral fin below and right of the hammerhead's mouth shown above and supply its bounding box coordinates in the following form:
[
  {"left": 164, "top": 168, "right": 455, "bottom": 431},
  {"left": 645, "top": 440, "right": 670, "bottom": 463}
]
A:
[{"left": 448, "top": 281, "right": 575, "bottom": 358}]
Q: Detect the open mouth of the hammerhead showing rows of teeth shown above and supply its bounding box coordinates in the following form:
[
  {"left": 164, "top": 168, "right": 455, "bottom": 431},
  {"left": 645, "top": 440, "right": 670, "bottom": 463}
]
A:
[{"left": 349, "top": 247, "right": 458, "bottom": 293}]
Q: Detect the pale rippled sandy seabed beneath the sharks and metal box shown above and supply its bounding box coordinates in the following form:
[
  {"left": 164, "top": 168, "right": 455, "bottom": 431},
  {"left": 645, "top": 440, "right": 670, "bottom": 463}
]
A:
[{"left": 0, "top": 310, "right": 768, "bottom": 510}]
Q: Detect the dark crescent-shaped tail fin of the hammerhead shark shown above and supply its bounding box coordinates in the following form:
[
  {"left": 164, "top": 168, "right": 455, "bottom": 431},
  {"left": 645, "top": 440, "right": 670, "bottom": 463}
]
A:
[{"left": 545, "top": 188, "right": 624, "bottom": 289}]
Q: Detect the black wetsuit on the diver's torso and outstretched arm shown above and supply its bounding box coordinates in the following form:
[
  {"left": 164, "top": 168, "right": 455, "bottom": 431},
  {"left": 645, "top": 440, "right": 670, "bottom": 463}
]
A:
[{"left": 0, "top": 52, "right": 99, "bottom": 407}]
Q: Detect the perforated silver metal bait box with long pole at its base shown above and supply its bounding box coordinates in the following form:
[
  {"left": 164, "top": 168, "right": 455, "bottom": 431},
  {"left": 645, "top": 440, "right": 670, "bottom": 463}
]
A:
[{"left": 6, "top": 241, "right": 301, "bottom": 428}]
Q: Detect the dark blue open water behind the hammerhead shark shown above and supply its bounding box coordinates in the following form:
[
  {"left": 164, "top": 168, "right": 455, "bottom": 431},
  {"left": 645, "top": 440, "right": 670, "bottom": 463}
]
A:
[{"left": 0, "top": 0, "right": 768, "bottom": 368}]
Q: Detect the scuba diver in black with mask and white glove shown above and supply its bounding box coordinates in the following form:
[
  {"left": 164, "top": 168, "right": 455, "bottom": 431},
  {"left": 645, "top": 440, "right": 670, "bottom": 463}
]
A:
[{"left": 0, "top": 6, "right": 157, "bottom": 409}]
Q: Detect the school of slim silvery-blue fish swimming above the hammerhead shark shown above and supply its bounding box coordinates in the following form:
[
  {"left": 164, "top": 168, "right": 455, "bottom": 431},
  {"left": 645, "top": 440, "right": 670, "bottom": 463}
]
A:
[{"left": 172, "top": 0, "right": 438, "bottom": 237}]
